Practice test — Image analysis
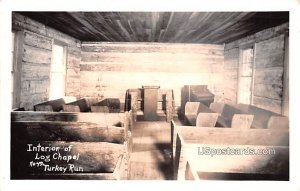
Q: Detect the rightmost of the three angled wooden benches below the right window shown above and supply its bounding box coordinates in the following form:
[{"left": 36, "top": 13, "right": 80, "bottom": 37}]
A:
[{"left": 233, "top": 104, "right": 289, "bottom": 129}]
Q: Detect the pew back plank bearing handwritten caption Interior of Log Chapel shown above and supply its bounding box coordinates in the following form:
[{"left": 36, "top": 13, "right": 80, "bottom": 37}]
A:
[{"left": 11, "top": 142, "right": 126, "bottom": 179}]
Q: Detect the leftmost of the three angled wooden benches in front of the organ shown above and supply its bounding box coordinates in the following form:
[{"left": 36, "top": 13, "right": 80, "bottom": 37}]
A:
[{"left": 184, "top": 102, "right": 218, "bottom": 126}]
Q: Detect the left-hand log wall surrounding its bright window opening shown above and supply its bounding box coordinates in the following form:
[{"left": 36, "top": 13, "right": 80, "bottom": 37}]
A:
[{"left": 12, "top": 13, "right": 81, "bottom": 110}]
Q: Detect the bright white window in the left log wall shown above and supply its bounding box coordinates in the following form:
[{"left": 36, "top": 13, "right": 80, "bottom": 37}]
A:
[{"left": 49, "top": 42, "right": 66, "bottom": 100}]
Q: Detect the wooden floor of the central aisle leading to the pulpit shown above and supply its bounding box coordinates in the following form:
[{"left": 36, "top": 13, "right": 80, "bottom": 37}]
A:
[{"left": 130, "top": 121, "right": 173, "bottom": 180}]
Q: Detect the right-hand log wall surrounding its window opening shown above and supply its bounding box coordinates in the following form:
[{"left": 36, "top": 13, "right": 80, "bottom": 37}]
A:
[{"left": 224, "top": 23, "right": 289, "bottom": 113}]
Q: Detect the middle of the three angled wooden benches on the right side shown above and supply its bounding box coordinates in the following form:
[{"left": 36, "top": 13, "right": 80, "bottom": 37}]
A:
[{"left": 210, "top": 102, "right": 254, "bottom": 129}]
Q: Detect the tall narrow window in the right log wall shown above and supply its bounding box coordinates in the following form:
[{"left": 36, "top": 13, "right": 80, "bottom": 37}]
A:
[{"left": 237, "top": 47, "right": 254, "bottom": 104}]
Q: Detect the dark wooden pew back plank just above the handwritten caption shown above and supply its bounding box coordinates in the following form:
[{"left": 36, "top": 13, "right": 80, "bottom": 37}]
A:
[{"left": 11, "top": 121, "right": 125, "bottom": 143}]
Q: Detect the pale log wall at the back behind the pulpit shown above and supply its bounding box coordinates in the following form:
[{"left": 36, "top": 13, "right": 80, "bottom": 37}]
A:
[{"left": 80, "top": 42, "right": 224, "bottom": 106}]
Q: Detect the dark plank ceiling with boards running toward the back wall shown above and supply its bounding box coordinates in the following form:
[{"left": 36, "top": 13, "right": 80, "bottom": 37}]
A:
[{"left": 19, "top": 12, "right": 289, "bottom": 44}]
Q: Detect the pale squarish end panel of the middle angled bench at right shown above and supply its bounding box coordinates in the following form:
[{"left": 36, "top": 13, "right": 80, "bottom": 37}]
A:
[{"left": 231, "top": 114, "right": 254, "bottom": 129}]
